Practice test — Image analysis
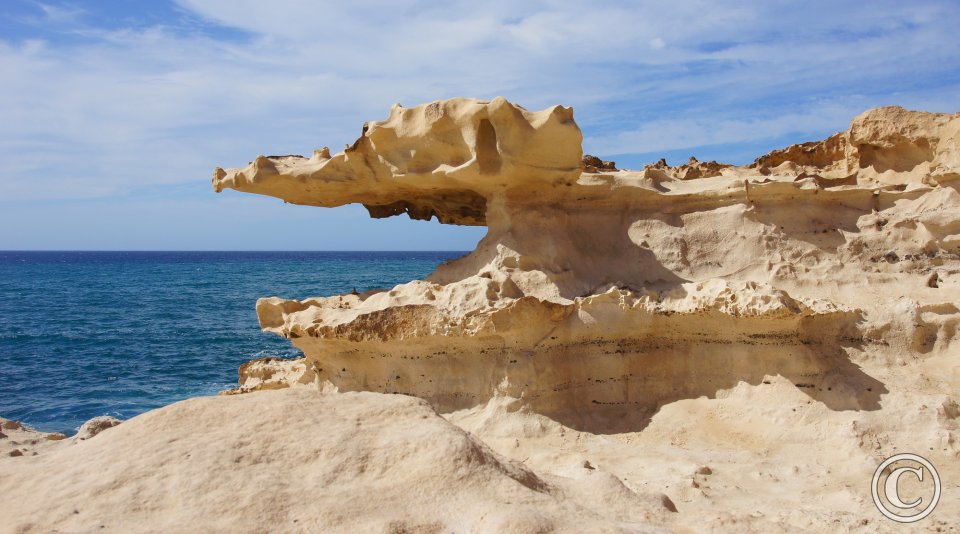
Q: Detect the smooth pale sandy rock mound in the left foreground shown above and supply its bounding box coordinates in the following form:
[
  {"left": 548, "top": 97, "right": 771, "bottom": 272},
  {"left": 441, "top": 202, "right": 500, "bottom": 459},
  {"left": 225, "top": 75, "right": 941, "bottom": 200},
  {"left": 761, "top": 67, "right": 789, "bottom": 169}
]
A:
[{"left": 0, "top": 388, "right": 675, "bottom": 532}]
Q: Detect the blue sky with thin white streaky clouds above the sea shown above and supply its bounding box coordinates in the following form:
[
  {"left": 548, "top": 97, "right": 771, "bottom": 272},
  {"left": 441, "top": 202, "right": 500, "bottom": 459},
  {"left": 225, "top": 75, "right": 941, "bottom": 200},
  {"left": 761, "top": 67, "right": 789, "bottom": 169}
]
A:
[{"left": 0, "top": 0, "right": 960, "bottom": 250}]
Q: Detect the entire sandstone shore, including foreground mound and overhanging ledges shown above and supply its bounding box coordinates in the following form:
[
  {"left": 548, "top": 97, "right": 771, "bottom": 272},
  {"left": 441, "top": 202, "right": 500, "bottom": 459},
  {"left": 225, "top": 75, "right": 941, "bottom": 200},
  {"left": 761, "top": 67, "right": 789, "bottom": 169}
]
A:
[{"left": 0, "top": 98, "right": 960, "bottom": 533}]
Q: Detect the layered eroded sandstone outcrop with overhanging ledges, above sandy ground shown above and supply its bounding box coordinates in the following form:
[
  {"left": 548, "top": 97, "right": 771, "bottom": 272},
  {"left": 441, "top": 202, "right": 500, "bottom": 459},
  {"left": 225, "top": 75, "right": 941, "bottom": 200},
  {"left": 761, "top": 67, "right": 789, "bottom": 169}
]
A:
[{"left": 214, "top": 99, "right": 960, "bottom": 438}]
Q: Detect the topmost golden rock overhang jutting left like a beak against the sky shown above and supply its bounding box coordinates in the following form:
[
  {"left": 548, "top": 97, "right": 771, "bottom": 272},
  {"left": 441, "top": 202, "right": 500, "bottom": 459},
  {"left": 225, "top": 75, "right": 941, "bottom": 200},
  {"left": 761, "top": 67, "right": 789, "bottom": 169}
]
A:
[{"left": 213, "top": 98, "right": 582, "bottom": 225}]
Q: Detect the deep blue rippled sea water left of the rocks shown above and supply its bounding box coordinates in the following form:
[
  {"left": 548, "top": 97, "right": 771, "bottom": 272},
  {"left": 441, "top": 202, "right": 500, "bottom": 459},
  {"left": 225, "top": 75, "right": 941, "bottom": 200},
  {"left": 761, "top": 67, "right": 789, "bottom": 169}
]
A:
[{"left": 0, "top": 252, "right": 464, "bottom": 434}]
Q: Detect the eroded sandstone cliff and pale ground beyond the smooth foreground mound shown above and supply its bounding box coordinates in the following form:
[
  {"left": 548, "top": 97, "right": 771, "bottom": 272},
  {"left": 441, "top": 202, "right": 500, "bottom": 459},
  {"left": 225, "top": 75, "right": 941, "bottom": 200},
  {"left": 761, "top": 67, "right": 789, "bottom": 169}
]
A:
[{"left": 214, "top": 99, "right": 960, "bottom": 531}]
